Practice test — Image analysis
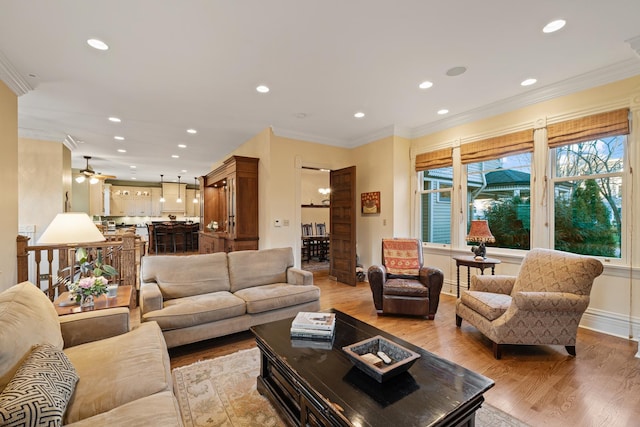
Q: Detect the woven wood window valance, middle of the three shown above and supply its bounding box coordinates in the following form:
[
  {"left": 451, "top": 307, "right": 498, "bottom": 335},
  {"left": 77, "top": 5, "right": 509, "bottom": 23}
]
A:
[{"left": 460, "top": 129, "right": 533, "bottom": 164}]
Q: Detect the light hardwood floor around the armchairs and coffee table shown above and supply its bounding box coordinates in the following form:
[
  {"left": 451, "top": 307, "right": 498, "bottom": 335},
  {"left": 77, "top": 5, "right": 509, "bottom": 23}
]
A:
[{"left": 152, "top": 276, "right": 640, "bottom": 427}]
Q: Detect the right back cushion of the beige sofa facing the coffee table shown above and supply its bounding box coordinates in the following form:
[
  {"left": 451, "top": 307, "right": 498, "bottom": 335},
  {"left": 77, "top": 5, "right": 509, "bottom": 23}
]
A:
[{"left": 227, "top": 248, "right": 293, "bottom": 293}]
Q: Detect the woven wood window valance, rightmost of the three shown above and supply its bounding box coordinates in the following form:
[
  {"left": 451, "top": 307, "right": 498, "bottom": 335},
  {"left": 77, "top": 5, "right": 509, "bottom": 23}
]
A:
[{"left": 547, "top": 108, "right": 629, "bottom": 148}]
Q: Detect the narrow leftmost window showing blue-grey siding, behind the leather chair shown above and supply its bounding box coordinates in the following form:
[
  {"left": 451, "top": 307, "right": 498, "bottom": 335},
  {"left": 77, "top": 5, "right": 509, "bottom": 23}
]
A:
[{"left": 419, "top": 167, "right": 453, "bottom": 244}]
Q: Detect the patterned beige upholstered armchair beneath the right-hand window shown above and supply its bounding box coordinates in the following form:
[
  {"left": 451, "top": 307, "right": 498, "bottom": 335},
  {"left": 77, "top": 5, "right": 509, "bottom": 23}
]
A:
[{"left": 456, "top": 249, "right": 603, "bottom": 359}]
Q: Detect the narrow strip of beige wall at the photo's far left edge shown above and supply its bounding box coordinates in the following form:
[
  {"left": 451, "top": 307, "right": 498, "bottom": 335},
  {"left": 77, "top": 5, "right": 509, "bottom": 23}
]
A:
[{"left": 0, "top": 81, "right": 18, "bottom": 290}]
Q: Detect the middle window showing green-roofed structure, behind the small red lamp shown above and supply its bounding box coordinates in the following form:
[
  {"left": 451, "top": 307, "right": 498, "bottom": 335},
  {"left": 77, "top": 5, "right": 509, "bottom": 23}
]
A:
[{"left": 467, "top": 153, "right": 531, "bottom": 249}]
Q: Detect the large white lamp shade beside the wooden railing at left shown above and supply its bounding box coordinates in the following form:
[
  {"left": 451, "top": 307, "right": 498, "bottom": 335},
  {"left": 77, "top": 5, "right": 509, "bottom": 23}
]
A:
[{"left": 38, "top": 212, "right": 106, "bottom": 245}]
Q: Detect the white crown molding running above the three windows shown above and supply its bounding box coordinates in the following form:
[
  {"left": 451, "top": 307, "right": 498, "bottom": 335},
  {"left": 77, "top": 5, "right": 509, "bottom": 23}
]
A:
[{"left": 411, "top": 57, "right": 640, "bottom": 138}]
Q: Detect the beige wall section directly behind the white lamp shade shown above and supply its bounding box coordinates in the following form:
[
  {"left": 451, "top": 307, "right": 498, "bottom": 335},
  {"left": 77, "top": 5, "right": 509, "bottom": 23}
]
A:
[{"left": 18, "top": 138, "right": 71, "bottom": 245}]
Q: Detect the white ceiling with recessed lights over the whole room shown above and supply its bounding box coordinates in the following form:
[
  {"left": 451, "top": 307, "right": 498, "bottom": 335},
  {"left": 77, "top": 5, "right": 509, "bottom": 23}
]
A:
[{"left": 0, "top": 0, "right": 640, "bottom": 183}]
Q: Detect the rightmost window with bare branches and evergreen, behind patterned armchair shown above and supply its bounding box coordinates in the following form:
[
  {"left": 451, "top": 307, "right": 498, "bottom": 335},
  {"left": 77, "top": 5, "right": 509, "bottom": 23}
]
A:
[{"left": 552, "top": 135, "right": 626, "bottom": 258}]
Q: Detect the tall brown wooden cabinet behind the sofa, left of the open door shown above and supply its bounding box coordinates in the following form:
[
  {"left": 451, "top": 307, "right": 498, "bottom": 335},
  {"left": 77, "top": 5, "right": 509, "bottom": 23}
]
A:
[{"left": 199, "top": 156, "right": 259, "bottom": 253}]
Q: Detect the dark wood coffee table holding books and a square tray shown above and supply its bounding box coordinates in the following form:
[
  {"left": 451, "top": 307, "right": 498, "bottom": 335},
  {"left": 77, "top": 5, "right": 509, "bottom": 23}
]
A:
[{"left": 251, "top": 310, "right": 494, "bottom": 427}]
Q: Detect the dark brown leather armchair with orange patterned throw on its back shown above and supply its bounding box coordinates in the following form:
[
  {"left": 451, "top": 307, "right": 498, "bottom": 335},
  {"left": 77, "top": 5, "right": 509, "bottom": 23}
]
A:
[{"left": 368, "top": 239, "right": 444, "bottom": 320}]
